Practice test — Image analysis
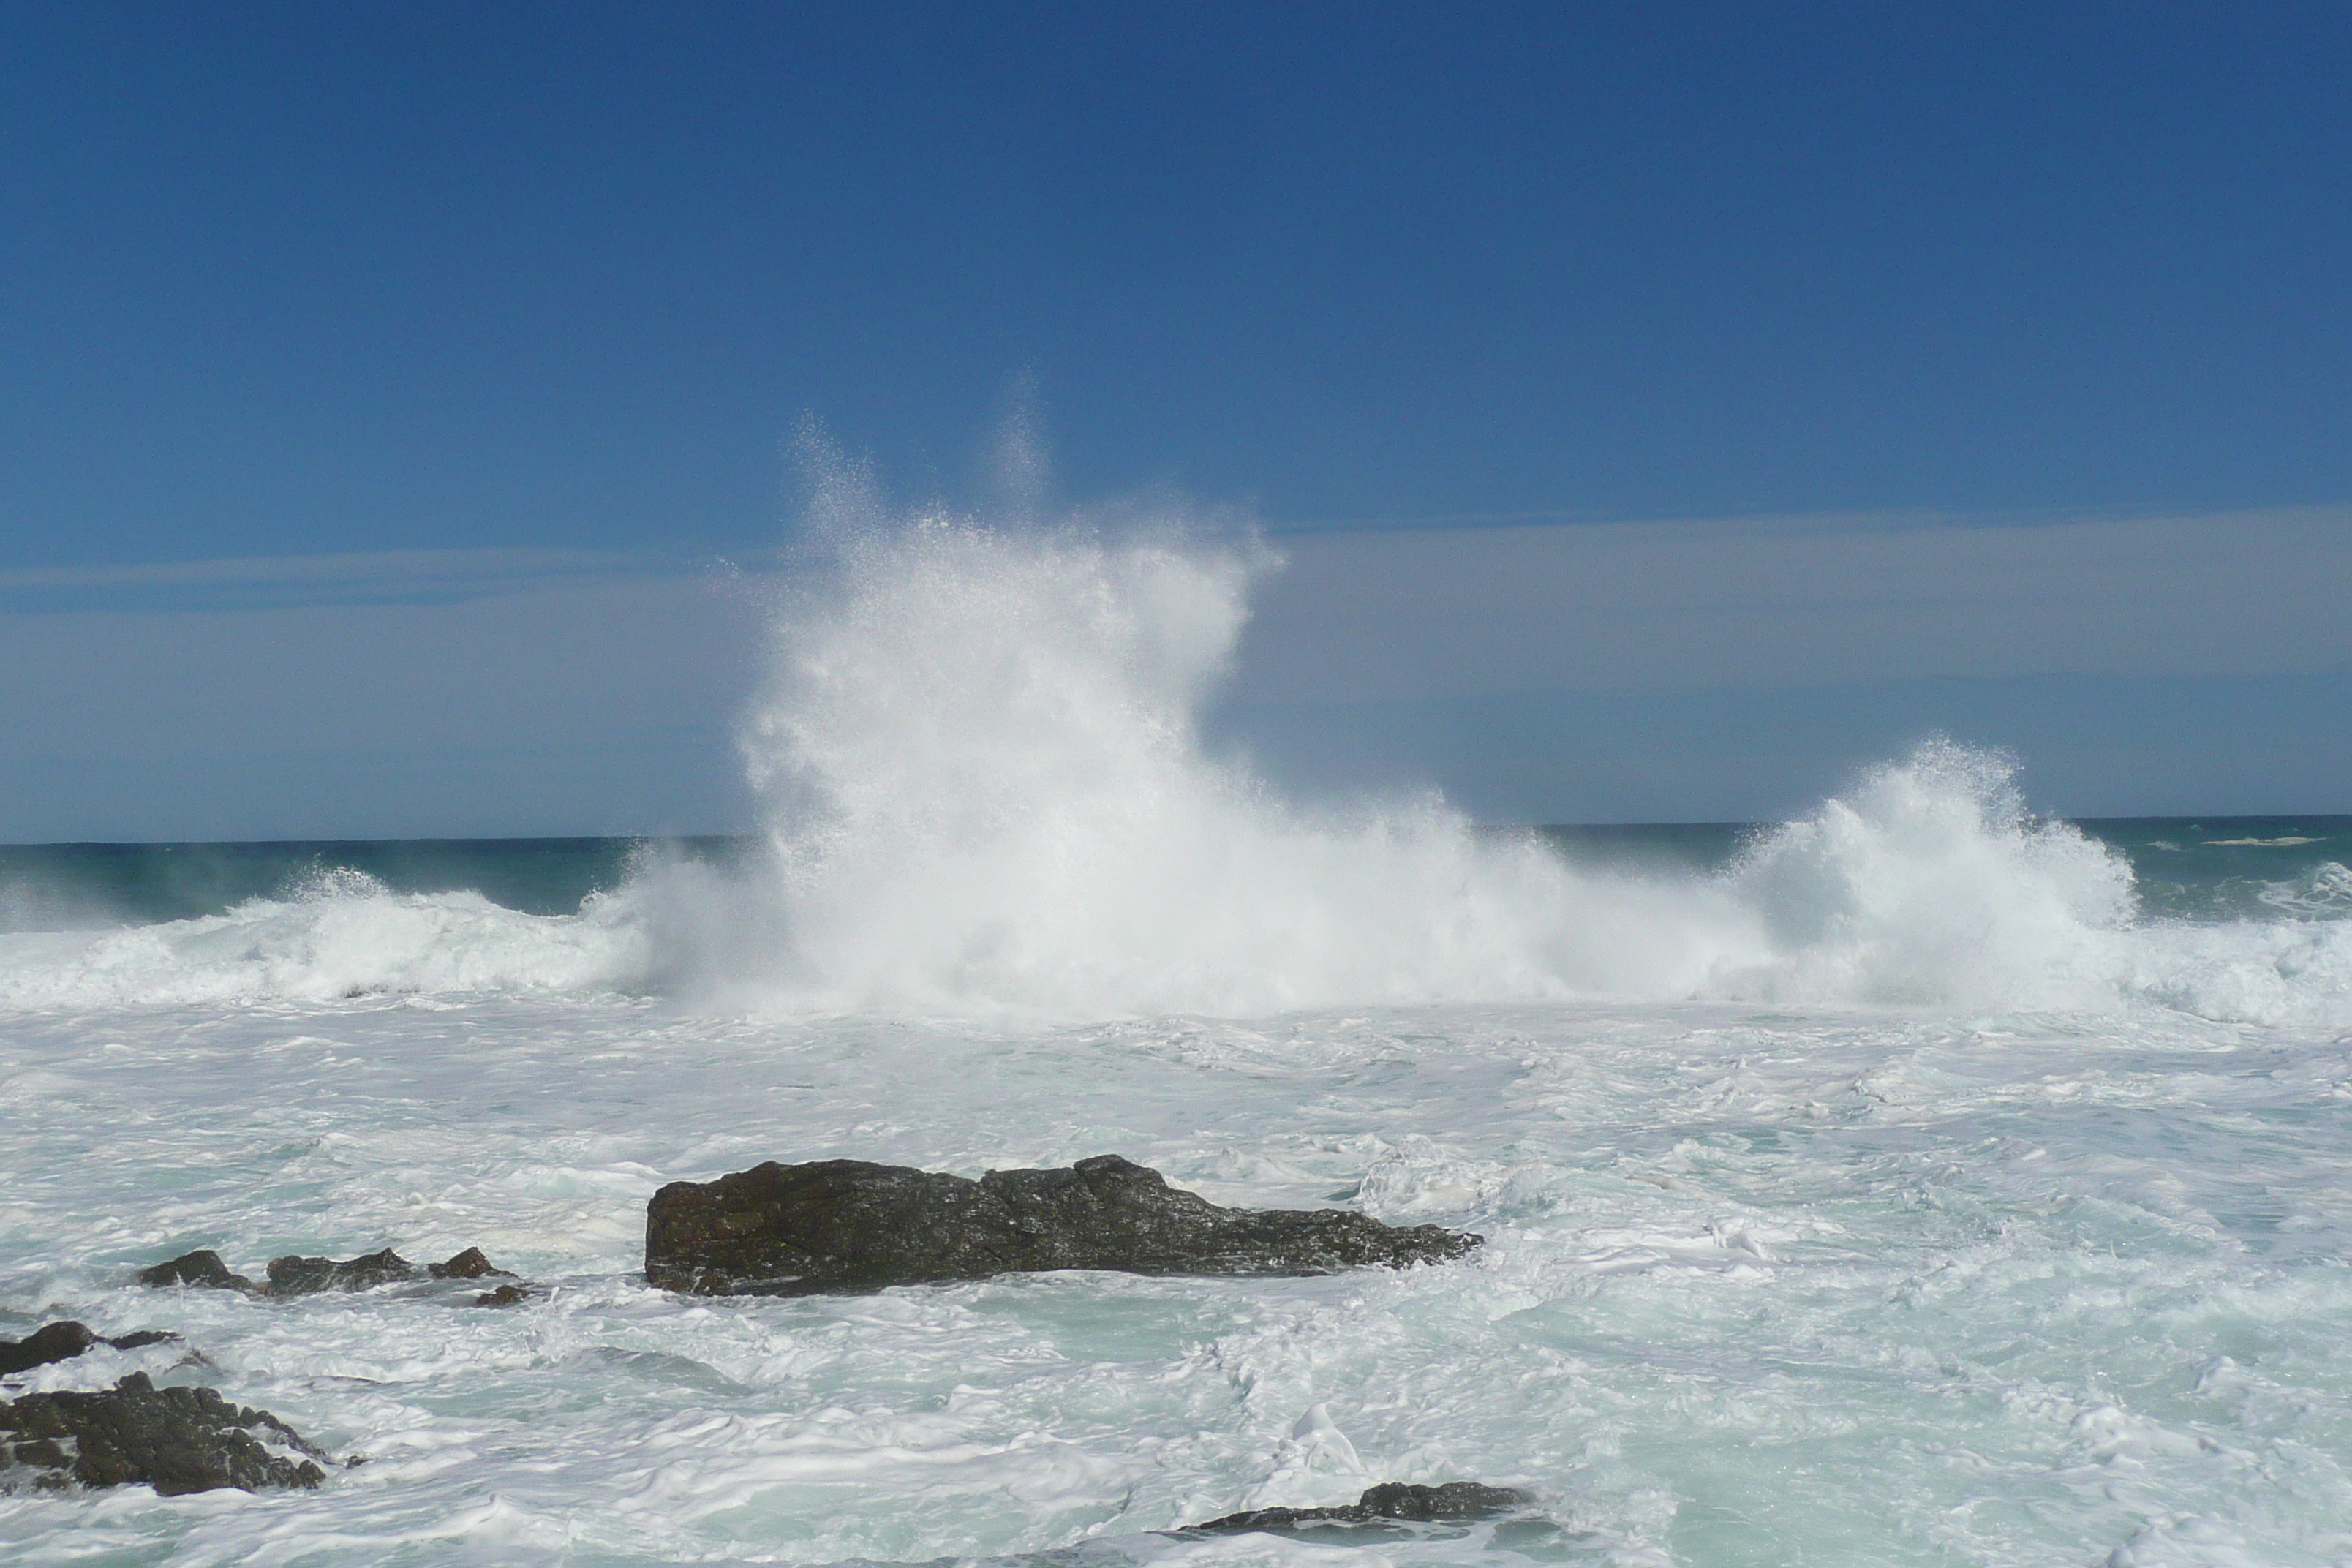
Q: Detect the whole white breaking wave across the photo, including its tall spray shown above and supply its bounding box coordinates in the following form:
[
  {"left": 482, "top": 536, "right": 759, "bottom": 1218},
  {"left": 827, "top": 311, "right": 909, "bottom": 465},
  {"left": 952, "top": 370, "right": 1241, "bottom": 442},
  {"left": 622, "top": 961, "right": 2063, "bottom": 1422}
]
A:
[{"left": 0, "top": 505, "right": 2352, "bottom": 1022}]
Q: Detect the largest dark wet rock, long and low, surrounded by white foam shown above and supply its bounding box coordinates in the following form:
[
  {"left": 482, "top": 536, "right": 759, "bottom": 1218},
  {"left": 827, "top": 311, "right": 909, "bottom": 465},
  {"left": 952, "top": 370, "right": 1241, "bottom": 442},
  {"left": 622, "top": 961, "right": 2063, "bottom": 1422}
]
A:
[{"left": 644, "top": 1154, "right": 1482, "bottom": 1295}]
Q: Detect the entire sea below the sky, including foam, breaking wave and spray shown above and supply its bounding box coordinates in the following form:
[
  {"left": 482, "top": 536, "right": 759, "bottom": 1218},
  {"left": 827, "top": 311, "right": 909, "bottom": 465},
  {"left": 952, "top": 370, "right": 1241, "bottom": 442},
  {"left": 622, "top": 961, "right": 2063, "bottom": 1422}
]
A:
[{"left": 0, "top": 517, "right": 2352, "bottom": 1568}]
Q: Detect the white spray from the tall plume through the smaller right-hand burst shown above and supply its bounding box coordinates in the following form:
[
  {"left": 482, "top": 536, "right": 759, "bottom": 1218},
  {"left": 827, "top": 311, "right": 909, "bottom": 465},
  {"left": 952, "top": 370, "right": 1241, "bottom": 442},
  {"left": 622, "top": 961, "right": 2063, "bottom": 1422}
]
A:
[{"left": 687, "top": 505, "right": 2131, "bottom": 1016}]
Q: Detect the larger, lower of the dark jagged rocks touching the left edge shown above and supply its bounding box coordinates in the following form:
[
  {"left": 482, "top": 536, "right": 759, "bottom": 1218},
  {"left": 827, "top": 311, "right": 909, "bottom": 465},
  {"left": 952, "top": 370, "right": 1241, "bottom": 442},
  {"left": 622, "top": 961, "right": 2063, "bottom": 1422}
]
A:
[{"left": 0, "top": 1373, "right": 327, "bottom": 1498}]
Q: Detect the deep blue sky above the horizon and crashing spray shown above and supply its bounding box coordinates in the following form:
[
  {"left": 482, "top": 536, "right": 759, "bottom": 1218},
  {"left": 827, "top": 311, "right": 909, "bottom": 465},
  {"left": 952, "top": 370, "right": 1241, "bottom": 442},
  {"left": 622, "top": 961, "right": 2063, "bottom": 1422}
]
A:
[{"left": 0, "top": 2, "right": 2352, "bottom": 837}]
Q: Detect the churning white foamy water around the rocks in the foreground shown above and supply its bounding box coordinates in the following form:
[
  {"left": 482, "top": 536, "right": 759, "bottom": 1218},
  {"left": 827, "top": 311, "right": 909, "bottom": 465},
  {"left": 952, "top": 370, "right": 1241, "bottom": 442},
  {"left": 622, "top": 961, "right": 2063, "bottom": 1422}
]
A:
[{"left": 0, "top": 995, "right": 2352, "bottom": 1568}]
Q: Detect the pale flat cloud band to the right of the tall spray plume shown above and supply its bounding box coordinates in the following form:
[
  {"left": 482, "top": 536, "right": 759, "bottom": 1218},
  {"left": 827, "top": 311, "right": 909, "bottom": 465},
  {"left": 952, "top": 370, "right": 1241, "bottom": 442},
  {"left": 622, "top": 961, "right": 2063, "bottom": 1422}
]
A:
[{"left": 1235, "top": 508, "right": 2352, "bottom": 703}]
